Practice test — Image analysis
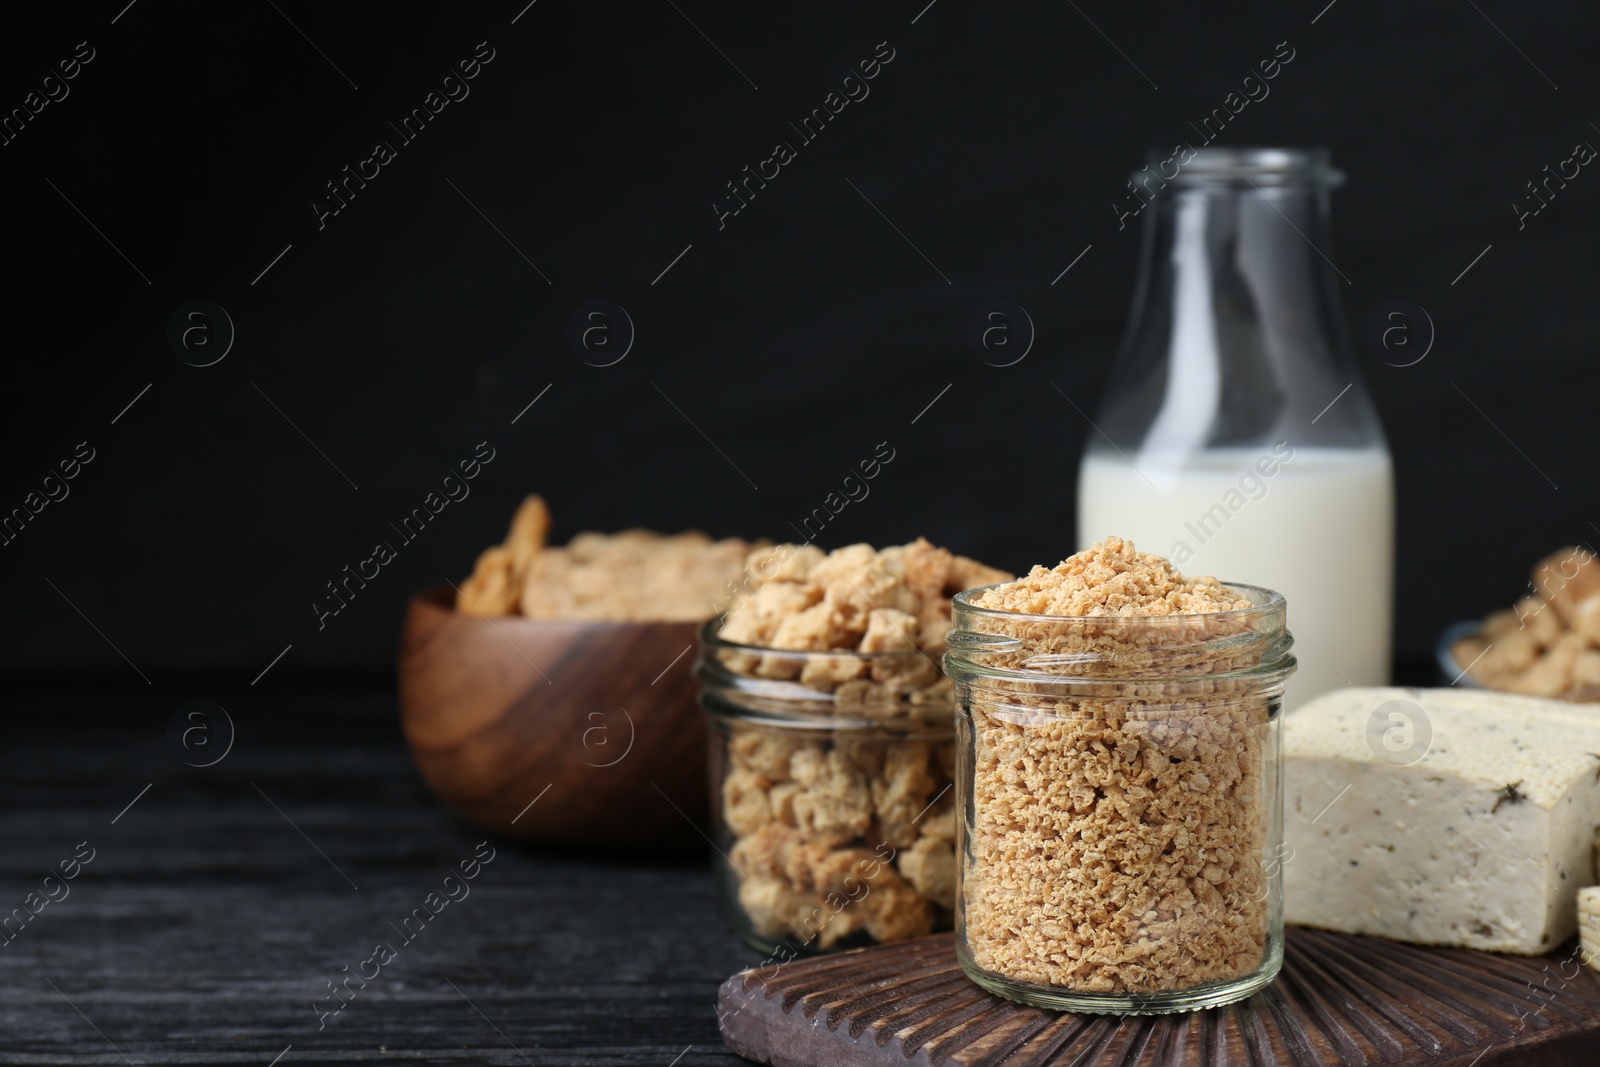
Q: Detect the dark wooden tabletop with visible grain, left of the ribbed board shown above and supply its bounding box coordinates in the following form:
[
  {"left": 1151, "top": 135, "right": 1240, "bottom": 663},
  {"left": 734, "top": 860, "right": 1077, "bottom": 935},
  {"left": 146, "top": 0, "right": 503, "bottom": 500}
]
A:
[{"left": 0, "top": 688, "right": 760, "bottom": 1067}]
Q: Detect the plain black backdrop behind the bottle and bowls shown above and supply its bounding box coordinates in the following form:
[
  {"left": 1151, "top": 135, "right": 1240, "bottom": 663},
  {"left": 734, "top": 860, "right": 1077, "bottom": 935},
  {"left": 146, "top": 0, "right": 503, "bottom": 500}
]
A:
[{"left": 0, "top": 0, "right": 1600, "bottom": 688}]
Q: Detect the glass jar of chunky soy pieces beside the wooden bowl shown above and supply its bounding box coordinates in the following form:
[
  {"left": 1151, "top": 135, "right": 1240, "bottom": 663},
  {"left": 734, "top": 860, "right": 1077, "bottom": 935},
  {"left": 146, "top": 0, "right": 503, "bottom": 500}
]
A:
[{"left": 694, "top": 621, "right": 955, "bottom": 958}]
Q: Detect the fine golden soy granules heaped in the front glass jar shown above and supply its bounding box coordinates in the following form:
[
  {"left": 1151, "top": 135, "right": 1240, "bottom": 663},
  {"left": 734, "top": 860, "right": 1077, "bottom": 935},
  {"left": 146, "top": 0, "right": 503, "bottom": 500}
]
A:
[{"left": 962, "top": 537, "right": 1270, "bottom": 993}]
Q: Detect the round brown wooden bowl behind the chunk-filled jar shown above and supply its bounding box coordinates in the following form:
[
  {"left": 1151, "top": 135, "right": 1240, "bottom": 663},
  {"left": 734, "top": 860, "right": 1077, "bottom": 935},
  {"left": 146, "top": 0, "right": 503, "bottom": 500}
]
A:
[{"left": 400, "top": 585, "right": 709, "bottom": 851}]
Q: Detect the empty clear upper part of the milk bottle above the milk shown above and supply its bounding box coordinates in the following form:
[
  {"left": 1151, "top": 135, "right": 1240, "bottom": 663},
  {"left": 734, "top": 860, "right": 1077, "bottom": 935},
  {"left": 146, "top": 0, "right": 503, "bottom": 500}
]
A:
[{"left": 1101, "top": 174, "right": 1382, "bottom": 466}]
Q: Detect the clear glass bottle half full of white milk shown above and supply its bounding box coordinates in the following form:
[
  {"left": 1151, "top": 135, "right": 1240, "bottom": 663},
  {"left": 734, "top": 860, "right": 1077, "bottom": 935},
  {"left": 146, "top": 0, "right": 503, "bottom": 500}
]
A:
[{"left": 1078, "top": 147, "right": 1394, "bottom": 710}]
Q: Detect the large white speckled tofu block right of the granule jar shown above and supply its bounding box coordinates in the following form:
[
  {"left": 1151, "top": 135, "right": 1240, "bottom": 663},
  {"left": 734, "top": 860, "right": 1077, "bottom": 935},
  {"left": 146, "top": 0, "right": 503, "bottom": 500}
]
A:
[{"left": 1283, "top": 688, "right": 1600, "bottom": 955}]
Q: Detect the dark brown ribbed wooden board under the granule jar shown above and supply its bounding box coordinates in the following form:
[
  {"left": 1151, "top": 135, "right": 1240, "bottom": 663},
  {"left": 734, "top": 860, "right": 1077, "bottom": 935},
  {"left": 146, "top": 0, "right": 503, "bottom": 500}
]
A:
[{"left": 718, "top": 928, "right": 1600, "bottom": 1067}]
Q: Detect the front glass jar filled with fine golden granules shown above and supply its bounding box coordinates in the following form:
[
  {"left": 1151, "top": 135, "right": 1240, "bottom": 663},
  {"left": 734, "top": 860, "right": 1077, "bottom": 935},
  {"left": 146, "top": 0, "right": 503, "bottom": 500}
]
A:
[{"left": 944, "top": 585, "right": 1294, "bottom": 1014}]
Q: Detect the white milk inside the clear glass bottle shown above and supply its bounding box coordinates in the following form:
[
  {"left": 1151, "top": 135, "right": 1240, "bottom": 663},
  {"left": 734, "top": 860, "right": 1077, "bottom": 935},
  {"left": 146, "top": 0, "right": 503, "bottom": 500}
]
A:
[{"left": 1078, "top": 445, "right": 1394, "bottom": 710}]
